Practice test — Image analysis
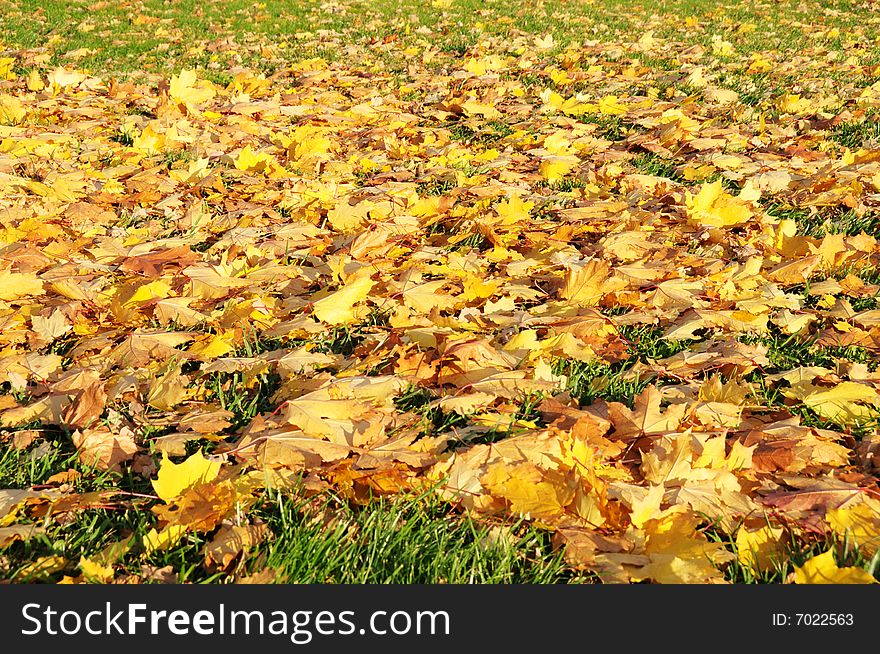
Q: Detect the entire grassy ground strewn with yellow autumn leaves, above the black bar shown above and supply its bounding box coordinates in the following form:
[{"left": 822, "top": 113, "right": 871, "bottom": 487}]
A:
[{"left": 0, "top": 0, "right": 880, "bottom": 583}]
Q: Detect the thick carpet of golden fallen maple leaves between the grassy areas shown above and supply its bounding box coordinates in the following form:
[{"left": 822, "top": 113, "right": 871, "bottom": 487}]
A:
[{"left": 0, "top": 3, "right": 880, "bottom": 583}]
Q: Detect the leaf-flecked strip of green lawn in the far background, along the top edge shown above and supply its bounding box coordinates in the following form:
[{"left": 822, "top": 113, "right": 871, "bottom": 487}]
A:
[{"left": 0, "top": 0, "right": 877, "bottom": 82}]
